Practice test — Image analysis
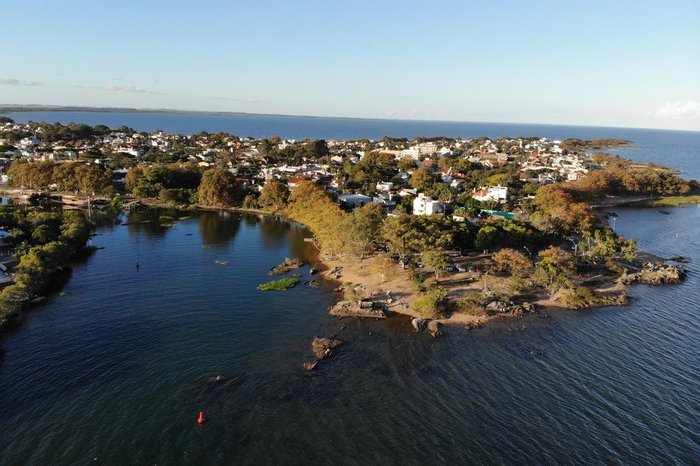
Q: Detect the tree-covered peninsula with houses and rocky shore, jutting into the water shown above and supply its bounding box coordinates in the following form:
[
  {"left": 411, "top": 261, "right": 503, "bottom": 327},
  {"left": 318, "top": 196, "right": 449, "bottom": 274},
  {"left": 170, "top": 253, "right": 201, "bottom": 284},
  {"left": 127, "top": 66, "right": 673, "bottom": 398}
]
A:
[{"left": 0, "top": 119, "right": 700, "bottom": 334}]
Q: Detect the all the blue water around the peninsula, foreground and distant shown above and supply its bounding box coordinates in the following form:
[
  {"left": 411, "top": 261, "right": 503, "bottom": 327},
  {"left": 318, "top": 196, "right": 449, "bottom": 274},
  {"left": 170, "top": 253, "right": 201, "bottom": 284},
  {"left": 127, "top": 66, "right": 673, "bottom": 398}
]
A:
[{"left": 0, "top": 112, "right": 700, "bottom": 465}]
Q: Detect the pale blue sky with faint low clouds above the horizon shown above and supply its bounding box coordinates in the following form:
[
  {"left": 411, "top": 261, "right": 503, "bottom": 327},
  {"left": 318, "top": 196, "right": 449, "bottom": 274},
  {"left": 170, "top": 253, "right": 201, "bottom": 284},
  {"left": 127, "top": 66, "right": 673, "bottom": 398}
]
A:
[{"left": 0, "top": 0, "right": 700, "bottom": 130}]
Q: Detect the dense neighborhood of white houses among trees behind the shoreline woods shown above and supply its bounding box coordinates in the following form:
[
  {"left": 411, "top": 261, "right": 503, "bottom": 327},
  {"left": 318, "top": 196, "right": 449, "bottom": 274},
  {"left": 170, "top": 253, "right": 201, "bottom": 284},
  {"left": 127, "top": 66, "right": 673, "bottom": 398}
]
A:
[{"left": 0, "top": 118, "right": 599, "bottom": 226}]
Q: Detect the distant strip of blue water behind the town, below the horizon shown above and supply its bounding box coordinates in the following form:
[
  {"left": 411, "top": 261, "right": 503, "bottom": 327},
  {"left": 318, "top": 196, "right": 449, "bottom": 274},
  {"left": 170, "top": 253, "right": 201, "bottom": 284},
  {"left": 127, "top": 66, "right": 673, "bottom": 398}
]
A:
[{"left": 8, "top": 112, "right": 700, "bottom": 176}]
